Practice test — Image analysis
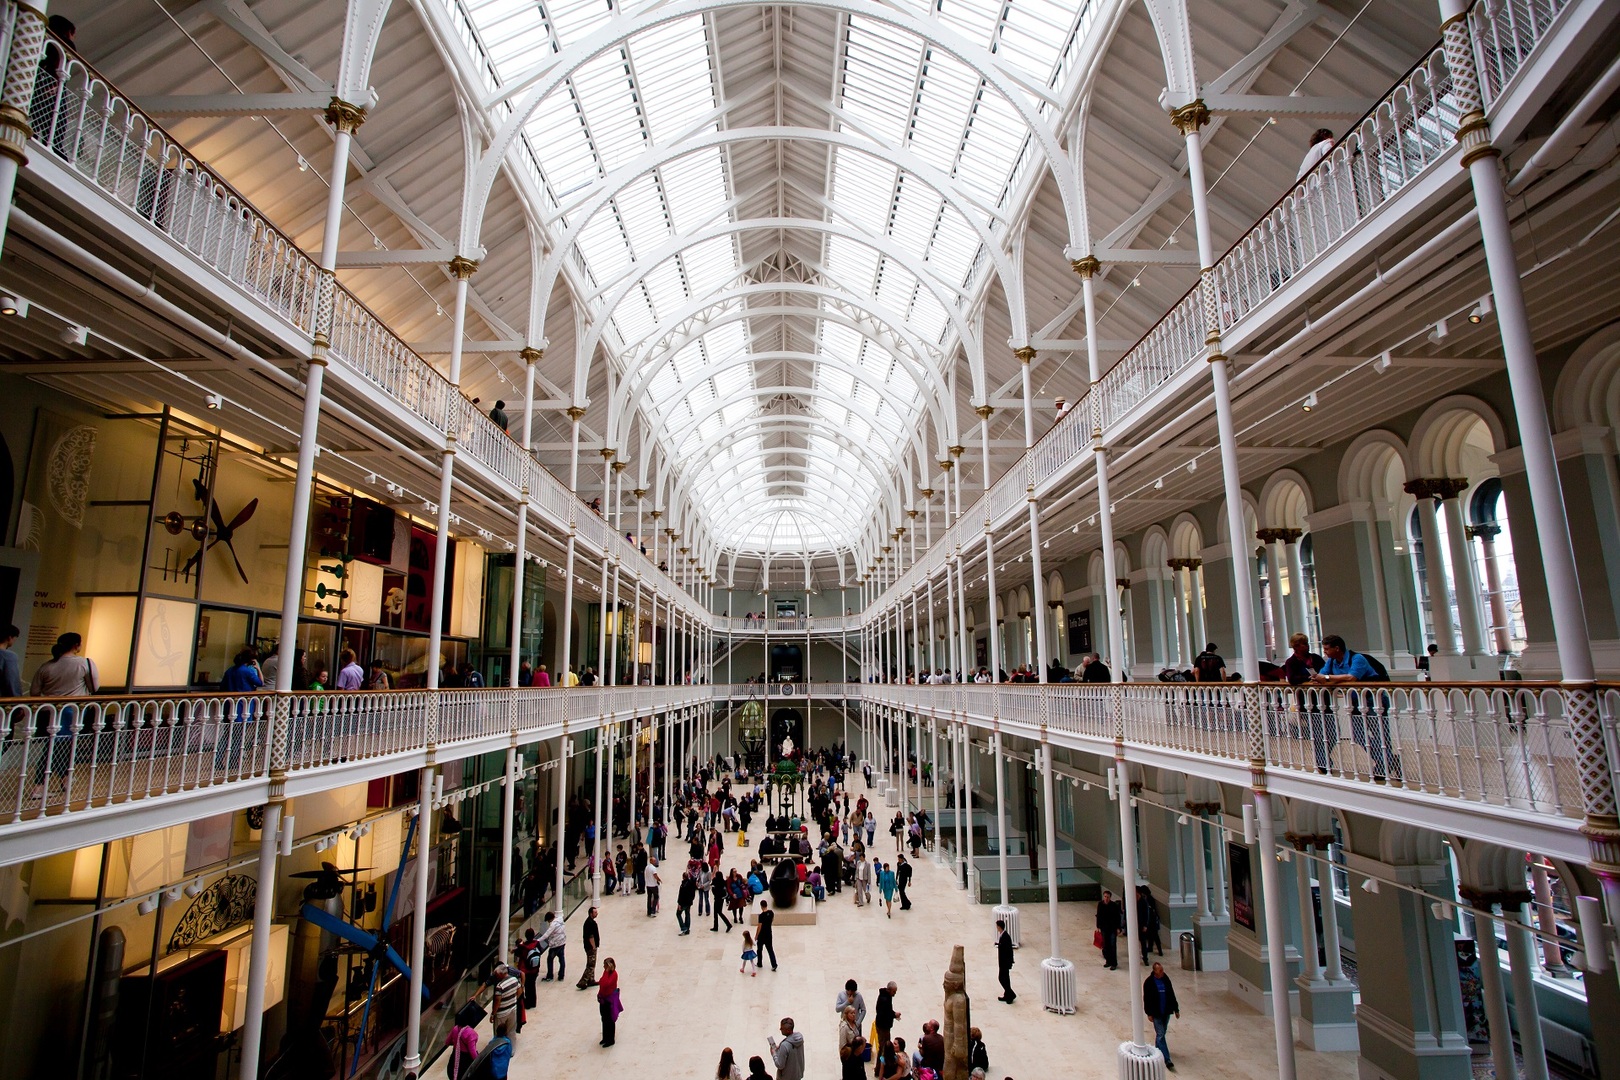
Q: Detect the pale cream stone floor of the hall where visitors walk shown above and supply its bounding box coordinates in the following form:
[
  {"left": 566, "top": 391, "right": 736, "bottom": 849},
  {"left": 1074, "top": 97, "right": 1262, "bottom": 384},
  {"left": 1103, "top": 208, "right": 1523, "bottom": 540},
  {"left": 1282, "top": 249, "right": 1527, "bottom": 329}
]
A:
[{"left": 473, "top": 799, "right": 1356, "bottom": 1080}]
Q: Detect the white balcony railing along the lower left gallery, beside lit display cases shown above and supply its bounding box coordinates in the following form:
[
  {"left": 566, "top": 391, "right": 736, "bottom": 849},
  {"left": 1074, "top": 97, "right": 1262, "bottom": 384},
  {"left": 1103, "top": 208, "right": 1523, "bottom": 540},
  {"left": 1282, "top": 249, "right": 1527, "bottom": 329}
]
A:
[{"left": 0, "top": 687, "right": 713, "bottom": 826}]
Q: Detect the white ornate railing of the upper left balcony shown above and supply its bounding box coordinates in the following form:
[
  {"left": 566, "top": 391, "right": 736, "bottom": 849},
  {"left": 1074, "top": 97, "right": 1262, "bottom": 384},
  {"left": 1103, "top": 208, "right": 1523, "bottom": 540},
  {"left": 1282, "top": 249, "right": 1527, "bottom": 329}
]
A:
[{"left": 15, "top": 33, "right": 701, "bottom": 615}]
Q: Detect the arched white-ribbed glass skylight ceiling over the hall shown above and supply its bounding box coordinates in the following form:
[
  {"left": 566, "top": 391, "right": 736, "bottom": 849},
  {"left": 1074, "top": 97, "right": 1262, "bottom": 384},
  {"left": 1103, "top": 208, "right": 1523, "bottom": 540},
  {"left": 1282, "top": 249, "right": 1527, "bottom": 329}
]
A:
[{"left": 446, "top": 0, "right": 1092, "bottom": 555}]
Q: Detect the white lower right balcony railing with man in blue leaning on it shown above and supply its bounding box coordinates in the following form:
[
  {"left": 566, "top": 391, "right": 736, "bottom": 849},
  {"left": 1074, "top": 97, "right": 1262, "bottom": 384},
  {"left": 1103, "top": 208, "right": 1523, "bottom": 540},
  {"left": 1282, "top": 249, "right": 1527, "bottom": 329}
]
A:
[{"left": 863, "top": 683, "right": 1587, "bottom": 819}]
